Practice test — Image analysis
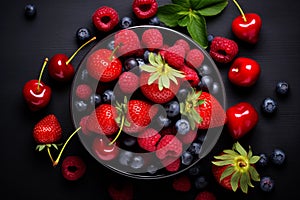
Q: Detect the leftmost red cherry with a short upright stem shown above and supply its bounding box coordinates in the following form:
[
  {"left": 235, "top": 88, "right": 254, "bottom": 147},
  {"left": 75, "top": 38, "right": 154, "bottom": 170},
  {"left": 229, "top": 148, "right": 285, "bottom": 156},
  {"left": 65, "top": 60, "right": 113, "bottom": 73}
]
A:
[{"left": 22, "top": 58, "right": 52, "bottom": 111}]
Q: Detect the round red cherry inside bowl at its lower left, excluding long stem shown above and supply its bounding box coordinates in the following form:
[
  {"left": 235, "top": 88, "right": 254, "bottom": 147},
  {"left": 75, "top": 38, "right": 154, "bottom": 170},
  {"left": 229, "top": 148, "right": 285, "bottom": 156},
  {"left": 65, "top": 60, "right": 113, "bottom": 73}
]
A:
[{"left": 92, "top": 137, "right": 119, "bottom": 161}]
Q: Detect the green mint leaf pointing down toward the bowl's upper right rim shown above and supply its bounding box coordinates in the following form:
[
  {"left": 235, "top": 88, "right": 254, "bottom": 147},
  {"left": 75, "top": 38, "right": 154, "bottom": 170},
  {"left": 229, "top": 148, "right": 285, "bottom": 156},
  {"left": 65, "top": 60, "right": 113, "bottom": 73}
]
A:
[{"left": 187, "top": 15, "right": 208, "bottom": 48}]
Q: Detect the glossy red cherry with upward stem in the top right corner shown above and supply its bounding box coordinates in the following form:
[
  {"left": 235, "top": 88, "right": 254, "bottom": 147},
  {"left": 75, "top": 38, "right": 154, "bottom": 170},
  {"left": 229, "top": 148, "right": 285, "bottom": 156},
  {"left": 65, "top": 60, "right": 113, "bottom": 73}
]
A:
[{"left": 231, "top": 0, "right": 262, "bottom": 44}]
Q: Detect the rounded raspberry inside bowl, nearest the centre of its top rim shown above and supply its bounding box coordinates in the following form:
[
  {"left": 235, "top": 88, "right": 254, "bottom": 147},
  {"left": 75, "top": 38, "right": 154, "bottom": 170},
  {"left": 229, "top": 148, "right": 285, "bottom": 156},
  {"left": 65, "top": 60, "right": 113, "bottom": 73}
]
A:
[{"left": 142, "top": 28, "right": 163, "bottom": 51}]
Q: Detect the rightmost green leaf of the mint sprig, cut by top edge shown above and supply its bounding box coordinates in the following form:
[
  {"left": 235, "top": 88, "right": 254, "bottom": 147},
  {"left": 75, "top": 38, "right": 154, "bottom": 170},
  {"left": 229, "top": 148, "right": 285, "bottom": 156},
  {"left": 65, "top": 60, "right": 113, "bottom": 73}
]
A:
[{"left": 198, "top": 0, "right": 228, "bottom": 16}]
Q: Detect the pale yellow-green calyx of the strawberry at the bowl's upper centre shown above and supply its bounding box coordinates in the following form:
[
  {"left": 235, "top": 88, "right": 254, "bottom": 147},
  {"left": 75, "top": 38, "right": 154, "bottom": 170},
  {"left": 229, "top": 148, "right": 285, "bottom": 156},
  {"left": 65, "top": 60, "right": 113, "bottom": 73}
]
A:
[{"left": 140, "top": 52, "right": 185, "bottom": 91}]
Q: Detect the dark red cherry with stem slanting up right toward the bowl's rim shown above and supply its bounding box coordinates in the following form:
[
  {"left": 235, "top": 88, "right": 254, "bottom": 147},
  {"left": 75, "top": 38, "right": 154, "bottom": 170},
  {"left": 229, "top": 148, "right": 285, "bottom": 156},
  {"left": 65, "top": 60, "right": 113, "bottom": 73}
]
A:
[{"left": 48, "top": 37, "right": 96, "bottom": 81}]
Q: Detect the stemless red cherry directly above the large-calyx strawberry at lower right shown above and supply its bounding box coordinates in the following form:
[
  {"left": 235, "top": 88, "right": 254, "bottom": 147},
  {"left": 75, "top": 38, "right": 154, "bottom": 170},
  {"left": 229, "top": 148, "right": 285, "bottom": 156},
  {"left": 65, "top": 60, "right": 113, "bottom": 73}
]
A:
[{"left": 226, "top": 102, "right": 258, "bottom": 139}]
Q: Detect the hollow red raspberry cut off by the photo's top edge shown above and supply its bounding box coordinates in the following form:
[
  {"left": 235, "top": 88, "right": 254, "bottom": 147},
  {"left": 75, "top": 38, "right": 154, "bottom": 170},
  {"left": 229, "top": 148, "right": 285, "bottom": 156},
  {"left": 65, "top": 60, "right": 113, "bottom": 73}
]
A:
[{"left": 132, "top": 0, "right": 158, "bottom": 19}]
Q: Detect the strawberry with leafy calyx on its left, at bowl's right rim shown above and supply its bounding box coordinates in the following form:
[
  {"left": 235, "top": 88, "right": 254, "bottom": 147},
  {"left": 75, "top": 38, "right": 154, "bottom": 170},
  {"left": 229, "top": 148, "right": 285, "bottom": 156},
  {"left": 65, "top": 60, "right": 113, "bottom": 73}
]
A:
[{"left": 180, "top": 91, "right": 226, "bottom": 130}]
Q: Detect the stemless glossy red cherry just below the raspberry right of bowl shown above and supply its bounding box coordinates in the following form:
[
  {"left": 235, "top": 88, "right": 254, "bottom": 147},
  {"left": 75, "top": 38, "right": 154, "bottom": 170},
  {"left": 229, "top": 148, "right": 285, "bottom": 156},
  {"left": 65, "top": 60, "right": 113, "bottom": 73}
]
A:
[{"left": 228, "top": 57, "right": 261, "bottom": 87}]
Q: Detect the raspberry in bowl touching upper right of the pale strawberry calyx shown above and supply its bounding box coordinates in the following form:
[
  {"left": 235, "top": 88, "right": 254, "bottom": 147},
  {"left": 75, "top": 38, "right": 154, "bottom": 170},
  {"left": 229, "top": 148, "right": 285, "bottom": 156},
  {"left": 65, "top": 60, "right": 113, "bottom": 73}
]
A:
[{"left": 164, "top": 45, "right": 185, "bottom": 69}]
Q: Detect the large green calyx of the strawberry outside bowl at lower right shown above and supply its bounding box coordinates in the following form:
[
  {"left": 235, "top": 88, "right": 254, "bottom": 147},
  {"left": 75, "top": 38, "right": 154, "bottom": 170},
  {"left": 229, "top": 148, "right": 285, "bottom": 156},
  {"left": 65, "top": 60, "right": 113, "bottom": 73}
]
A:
[{"left": 212, "top": 142, "right": 260, "bottom": 193}]
